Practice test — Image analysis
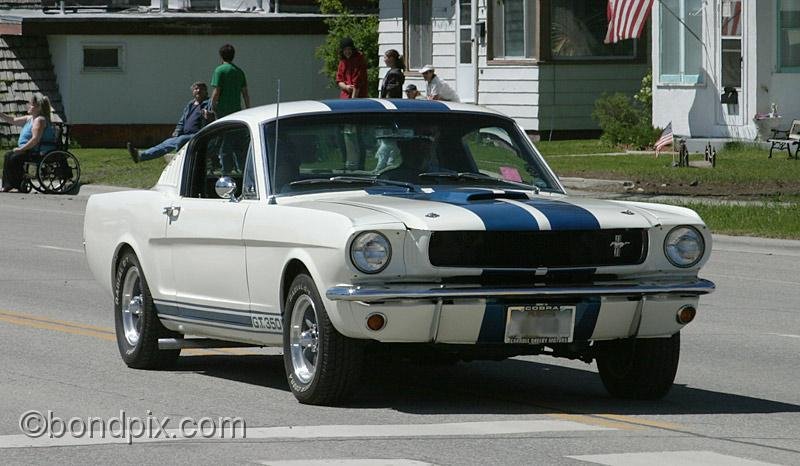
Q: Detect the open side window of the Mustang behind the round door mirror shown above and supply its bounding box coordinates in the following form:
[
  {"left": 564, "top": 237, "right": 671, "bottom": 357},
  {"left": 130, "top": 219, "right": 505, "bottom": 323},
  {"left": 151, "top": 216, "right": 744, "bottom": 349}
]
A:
[{"left": 182, "top": 126, "right": 253, "bottom": 199}]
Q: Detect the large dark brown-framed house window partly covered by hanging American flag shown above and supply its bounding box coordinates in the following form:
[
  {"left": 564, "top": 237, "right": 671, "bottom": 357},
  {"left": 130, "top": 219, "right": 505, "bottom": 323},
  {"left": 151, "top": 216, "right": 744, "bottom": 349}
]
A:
[{"left": 550, "top": 0, "right": 638, "bottom": 60}]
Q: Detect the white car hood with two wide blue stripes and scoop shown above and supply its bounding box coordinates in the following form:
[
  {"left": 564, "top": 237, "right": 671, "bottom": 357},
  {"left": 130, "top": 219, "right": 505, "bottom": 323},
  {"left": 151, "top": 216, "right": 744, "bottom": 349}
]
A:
[{"left": 308, "top": 188, "right": 701, "bottom": 231}]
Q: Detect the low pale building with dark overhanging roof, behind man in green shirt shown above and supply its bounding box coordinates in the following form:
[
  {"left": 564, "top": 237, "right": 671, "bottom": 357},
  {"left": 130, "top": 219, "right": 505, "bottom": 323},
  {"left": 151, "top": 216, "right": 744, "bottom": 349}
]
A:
[{"left": 0, "top": 0, "right": 338, "bottom": 147}]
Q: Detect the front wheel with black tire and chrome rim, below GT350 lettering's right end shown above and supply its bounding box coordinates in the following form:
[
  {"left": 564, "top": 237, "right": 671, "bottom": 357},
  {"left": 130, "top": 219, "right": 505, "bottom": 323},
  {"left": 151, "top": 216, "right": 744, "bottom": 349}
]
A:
[{"left": 283, "top": 274, "right": 364, "bottom": 405}]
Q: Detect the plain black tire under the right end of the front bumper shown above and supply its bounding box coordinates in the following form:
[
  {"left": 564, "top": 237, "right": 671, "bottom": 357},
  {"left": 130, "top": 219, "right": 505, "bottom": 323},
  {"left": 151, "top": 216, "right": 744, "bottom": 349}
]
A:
[{"left": 597, "top": 333, "right": 681, "bottom": 400}]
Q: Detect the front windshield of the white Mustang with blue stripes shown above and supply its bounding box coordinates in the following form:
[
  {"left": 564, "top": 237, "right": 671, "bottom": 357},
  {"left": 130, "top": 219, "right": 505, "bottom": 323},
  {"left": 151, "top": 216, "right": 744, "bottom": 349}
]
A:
[{"left": 264, "top": 112, "right": 559, "bottom": 195}]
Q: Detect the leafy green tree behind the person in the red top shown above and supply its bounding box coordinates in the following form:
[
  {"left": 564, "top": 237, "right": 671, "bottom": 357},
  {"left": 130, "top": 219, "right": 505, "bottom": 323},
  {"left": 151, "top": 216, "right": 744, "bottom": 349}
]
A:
[{"left": 316, "top": 0, "right": 379, "bottom": 97}]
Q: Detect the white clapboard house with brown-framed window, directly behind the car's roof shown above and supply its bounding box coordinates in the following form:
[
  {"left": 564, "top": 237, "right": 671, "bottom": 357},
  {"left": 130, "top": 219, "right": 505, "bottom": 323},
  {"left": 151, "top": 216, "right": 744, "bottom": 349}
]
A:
[{"left": 379, "top": 0, "right": 650, "bottom": 138}]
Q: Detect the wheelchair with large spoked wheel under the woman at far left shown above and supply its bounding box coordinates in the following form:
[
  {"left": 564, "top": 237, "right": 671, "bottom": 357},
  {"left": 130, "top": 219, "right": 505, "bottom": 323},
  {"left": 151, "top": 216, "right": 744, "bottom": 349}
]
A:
[{"left": 20, "top": 122, "right": 81, "bottom": 194}]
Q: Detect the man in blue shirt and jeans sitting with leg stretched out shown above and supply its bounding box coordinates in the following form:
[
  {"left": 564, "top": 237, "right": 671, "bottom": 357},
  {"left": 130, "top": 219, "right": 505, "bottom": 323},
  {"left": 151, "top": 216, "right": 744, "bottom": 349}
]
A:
[{"left": 128, "top": 82, "right": 213, "bottom": 163}]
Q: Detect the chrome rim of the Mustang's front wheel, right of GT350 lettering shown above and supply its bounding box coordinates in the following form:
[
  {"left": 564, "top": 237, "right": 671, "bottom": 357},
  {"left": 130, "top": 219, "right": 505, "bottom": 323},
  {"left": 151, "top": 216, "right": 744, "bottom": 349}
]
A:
[{"left": 289, "top": 295, "right": 319, "bottom": 384}]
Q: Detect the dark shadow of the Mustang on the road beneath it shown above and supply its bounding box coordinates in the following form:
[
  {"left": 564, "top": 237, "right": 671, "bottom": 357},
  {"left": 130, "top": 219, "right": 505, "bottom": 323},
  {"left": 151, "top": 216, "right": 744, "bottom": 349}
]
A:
[{"left": 169, "top": 355, "right": 800, "bottom": 415}]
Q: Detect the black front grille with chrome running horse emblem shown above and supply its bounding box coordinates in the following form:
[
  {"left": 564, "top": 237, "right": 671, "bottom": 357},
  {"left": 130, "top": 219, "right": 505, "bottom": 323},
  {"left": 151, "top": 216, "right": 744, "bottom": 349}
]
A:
[{"left": 428, "top": 229, "right": 647, "bottom": 269}]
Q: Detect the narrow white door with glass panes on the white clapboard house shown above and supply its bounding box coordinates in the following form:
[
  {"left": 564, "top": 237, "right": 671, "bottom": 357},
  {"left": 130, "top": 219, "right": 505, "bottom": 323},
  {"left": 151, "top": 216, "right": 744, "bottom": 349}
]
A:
[{"left": 456, "top": 0, "right": 478, "bottom": 103}]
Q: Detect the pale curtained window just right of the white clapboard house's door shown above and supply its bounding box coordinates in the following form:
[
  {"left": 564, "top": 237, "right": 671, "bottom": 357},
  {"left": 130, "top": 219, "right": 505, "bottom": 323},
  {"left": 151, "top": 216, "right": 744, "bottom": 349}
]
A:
[{"left": 491, "top": 0, "right": 538, "bottom": 58}]
